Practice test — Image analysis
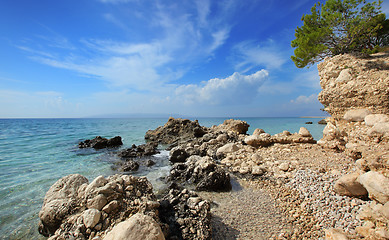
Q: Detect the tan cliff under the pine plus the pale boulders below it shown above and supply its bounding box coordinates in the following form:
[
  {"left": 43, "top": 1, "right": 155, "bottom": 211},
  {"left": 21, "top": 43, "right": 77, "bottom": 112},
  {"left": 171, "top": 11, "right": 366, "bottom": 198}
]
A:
[{"left": 318, "top": 52, "right": 389, "bottom": 239}]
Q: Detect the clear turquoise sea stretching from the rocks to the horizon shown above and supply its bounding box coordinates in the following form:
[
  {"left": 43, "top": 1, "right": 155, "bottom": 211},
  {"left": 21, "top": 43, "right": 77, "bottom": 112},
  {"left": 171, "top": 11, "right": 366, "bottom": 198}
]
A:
[{"left": 0, "top": 118, "right": 324, "bottom": 239}]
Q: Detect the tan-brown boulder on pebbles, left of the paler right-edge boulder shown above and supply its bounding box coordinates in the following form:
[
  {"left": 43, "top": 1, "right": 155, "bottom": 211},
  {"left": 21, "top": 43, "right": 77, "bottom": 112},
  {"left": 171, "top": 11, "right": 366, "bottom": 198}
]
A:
[{"left": 334, "top": 172, "right": 367, "bottom": 197}]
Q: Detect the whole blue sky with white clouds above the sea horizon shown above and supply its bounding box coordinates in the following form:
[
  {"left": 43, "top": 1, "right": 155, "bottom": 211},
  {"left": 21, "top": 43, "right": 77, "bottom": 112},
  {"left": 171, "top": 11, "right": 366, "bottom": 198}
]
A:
[{"left": 0, "top": 0, "right": 389, "bottom": 118}]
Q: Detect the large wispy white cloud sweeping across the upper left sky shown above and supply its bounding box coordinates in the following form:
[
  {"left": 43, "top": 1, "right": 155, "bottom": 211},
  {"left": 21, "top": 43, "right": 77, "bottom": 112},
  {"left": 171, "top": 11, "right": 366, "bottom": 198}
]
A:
[{"left": 19, "top": 0, "right": 230, "bottom": 90}]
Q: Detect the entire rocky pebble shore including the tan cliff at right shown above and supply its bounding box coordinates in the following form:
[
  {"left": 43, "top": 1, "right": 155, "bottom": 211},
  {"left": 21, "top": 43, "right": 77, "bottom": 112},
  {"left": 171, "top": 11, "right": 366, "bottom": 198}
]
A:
[{"left": 39, "top": 53, "right": 389, "bottom": 240}]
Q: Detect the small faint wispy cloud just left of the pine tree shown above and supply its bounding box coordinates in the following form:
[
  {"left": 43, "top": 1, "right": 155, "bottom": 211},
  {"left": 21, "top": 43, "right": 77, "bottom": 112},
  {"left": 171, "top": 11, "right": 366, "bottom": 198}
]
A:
[{"left": 230, "top": 40, "right": 288, "bottom": 72}]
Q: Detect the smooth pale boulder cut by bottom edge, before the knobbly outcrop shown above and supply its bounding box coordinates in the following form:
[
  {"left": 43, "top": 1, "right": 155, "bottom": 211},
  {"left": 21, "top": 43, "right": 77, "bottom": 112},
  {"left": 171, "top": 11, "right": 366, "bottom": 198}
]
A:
[{"left": 103, "top": 213, "right": 165, "bottom": 240}]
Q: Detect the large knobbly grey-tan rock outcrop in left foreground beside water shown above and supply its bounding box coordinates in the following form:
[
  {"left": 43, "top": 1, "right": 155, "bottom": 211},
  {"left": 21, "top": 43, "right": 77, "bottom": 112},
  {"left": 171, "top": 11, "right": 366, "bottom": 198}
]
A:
[{"left": 39, "top": 174, "right": 160, "bottom": 240}]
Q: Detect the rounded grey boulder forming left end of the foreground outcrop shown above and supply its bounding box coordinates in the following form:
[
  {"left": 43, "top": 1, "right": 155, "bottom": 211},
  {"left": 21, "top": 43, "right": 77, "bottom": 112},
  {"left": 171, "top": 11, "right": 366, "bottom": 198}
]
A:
[{"left": 39, "top": 174, "right": 88, "bottom": 236}]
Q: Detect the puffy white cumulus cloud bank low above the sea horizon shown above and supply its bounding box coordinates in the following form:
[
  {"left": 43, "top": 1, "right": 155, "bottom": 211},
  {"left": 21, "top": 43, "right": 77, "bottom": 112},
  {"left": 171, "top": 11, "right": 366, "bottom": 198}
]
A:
[{"left": 176, "top": 70, "right": 268, "bottom": 104}]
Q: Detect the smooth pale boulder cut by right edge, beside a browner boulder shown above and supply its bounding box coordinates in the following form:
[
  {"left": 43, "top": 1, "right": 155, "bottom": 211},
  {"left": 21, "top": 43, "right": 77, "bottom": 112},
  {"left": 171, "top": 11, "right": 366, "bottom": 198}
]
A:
[{"left": 358, "top": 171, "right": 389, "bottom": 204}]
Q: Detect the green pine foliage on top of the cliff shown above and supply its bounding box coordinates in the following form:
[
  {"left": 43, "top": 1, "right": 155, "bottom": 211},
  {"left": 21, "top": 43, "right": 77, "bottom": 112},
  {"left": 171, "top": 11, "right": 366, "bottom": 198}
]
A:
[{"left": 291, "top": 0, "right": 389, "bottom": 68}]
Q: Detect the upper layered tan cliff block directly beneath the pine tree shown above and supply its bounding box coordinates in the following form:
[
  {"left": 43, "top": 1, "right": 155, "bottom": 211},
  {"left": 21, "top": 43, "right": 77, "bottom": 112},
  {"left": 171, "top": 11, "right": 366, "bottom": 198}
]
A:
[{"left": 318, "top": 52, "right": 389, "bottom": 119}]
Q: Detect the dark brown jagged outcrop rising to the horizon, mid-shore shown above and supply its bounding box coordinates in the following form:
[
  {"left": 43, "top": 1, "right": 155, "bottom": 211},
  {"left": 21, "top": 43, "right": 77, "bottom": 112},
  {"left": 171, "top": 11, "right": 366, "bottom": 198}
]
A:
[{"left": 145, "top": 118, "right": 207, "bottom": 144}]
